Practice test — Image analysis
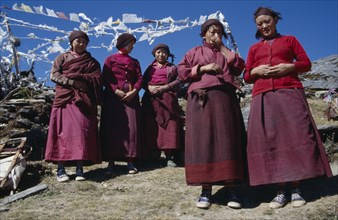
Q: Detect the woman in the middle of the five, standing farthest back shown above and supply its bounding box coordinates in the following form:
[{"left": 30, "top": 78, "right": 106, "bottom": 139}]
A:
[{"left": 142, "top": 44, "right": 181, "bottom": 167}]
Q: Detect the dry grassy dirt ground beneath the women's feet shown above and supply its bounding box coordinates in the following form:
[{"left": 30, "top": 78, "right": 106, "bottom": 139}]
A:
[{"left": 0, "top": 161, "right": 338, "bottom": 220}]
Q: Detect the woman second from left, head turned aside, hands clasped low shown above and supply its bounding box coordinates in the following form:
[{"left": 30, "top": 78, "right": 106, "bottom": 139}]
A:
[{"left": 100, "top": 33, "right": 142, "bottom": 175}]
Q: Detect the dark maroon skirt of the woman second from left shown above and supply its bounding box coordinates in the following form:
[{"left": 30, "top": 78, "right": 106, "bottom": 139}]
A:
[{"left": 100, "top": 93, "right": 142, "bottom": 161}]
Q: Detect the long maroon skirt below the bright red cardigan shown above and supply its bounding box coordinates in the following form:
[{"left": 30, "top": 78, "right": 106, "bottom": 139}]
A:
[{"left": 247, "top": 89, "right": 332, "bottom": 186}]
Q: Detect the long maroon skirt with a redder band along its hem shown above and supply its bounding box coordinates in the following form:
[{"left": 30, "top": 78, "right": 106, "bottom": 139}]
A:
[{"left": 185, "top": 89, "right": 245, "bottom": 185}]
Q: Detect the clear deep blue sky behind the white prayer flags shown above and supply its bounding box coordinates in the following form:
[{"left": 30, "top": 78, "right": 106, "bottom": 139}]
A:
[{"left": 1, "top": 0, "right": 338, "bottom": 85}]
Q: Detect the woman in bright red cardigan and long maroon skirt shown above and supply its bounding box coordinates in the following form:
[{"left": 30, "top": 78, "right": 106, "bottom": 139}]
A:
[{"left": 244, "top": 7, "right": 332, "bottom": 208}]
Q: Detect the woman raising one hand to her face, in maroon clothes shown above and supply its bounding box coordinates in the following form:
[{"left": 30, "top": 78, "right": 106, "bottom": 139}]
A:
[{"left": 178, "top": 19, "right": 245, "bottom": 208}]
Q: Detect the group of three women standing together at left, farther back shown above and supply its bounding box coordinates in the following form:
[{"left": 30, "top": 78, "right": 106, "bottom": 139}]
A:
[{"left": 45, "top": 31, "right": 181, "bottom": 178}]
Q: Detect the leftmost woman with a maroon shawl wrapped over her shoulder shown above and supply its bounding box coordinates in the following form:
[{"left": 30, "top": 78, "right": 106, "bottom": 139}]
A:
[{"left": 45, "top": 31, "right": 102, "bottom": 182}]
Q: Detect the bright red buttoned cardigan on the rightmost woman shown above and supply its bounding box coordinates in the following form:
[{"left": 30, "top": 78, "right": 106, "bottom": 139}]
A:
[{"left": 244, "top": 35, "right": 311, "bottom": 96}]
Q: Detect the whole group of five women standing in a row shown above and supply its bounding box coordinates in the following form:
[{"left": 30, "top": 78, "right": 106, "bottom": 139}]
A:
[{"left": 46, "top": 7, "right": 332, "bottom": 209}]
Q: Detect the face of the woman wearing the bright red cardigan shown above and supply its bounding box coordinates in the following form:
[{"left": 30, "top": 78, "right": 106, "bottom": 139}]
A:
[{"left": 255, "top": 15, "right": 278, "bottom": 38}]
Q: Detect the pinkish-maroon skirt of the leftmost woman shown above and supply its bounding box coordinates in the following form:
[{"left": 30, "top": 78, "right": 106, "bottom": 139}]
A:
[{"left": 45, "top": 103, "right": 101, "bottom": 163}]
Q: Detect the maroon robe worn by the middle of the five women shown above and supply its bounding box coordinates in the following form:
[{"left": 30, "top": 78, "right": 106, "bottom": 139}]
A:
[{"left": 142, "top": 62, "right": 181, "bottom": 158}]
